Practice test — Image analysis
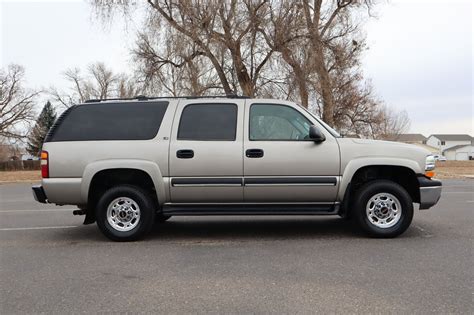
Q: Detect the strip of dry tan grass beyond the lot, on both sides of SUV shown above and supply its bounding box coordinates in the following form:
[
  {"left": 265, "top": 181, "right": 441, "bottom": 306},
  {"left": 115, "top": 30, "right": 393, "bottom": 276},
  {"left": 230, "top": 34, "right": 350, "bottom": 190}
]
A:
[{"left": 0, "top": 161, "right": 474, "bottom": 183}]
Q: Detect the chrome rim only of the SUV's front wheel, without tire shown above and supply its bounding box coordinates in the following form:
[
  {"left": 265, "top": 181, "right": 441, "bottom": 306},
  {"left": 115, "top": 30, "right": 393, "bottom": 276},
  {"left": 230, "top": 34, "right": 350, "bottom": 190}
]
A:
[{"left": 365, "top": 193, "right": 402, "bottom": 229}]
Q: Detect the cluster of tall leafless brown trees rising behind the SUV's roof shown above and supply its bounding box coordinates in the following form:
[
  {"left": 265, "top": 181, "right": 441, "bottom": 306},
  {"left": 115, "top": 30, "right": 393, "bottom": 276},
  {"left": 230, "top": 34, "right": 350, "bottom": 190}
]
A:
[{"left": 94, "top": 0, "right": 408, "bottom": 137}]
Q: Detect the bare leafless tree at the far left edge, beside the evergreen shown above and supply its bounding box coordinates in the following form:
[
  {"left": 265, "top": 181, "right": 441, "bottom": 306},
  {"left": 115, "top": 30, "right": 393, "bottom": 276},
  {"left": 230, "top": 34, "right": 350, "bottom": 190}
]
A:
[{"left": 0, "top": 64, "right": 39, "bottom": 140}]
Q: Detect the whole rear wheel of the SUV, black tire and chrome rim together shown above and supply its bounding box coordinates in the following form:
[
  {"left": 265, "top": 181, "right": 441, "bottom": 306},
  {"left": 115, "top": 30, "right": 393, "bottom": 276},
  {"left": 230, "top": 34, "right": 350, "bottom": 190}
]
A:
[{"left": 96, "top": 185, "right": 155, "bottom": 241}]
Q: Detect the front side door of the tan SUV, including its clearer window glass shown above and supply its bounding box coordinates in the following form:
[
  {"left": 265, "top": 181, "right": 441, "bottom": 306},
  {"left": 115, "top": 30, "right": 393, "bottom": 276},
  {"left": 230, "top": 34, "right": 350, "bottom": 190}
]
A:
[{"left": 244, "top": 100, "right": 340, "bottom": 203}]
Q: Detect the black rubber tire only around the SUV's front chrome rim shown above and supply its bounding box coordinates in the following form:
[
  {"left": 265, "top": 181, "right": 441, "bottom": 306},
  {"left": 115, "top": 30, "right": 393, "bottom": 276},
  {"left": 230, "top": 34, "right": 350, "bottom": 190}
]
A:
[{"left": 353, "top": 180, "right": 413, "bottom": 238}]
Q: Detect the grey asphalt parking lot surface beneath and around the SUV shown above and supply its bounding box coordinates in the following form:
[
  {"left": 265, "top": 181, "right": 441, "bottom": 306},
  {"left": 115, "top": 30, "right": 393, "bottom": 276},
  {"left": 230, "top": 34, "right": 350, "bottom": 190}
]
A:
[{"left": 0, "top": 180, "right": 474, "bottom": 314}]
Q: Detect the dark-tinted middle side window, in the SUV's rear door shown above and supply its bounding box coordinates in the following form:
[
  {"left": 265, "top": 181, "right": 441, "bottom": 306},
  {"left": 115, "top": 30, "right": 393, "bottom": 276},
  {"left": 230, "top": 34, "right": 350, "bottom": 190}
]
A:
[{"left": 178, "top": 103, "right": 237, "bottom": 141}]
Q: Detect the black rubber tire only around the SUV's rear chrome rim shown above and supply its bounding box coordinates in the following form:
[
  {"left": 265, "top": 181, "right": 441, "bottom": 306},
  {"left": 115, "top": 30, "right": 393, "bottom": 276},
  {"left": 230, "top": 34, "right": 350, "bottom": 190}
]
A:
[{"left": 96, "top": 185, "right": 156, "bottom": 242}]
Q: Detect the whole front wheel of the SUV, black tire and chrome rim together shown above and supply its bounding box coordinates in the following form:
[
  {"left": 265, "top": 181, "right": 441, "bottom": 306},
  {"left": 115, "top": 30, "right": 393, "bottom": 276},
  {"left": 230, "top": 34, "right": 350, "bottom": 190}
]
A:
[{"left": 354, "top": 180, "right": 413, "bottom": 238}]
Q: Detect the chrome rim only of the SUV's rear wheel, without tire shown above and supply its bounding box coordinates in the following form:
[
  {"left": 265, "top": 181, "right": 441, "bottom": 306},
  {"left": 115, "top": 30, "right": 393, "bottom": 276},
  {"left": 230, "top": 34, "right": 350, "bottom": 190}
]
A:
[{"left": 107, "top": 197, "right": 140, "bottom": 232}]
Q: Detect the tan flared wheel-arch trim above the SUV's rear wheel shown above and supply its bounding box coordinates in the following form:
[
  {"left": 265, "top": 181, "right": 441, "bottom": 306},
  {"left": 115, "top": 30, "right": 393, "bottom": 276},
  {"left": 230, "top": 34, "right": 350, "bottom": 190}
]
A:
[{"left": 81, "top": 159, "right": 166, "bottom": 205}]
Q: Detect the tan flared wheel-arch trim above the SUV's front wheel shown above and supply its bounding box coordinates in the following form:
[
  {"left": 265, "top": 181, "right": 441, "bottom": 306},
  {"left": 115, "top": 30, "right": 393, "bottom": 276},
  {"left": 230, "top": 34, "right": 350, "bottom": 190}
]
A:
[{"left": 338, "top": 157, "right": 424, "bottom": 201}]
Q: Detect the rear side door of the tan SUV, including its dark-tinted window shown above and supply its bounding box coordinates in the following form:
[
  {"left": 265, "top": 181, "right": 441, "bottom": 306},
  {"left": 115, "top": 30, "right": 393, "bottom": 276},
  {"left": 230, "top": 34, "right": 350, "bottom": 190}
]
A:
[{"left": 169, "top": 100, "right": 244, "bottom": 203}]
